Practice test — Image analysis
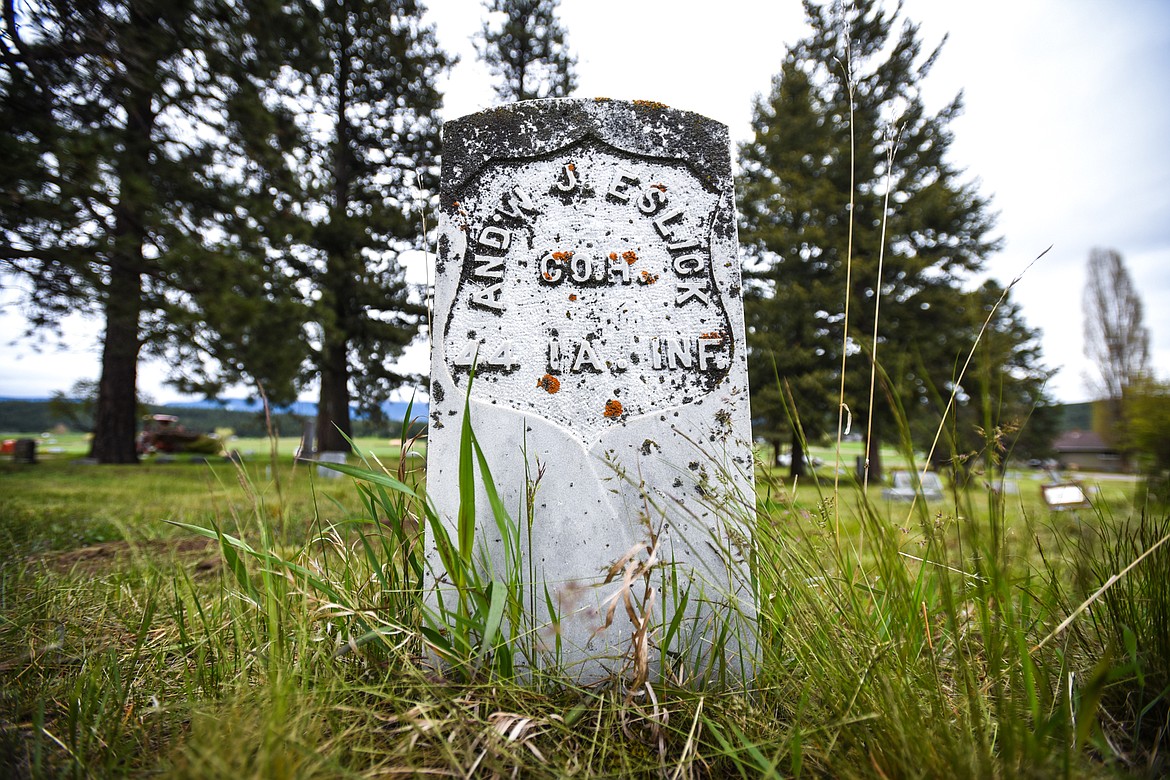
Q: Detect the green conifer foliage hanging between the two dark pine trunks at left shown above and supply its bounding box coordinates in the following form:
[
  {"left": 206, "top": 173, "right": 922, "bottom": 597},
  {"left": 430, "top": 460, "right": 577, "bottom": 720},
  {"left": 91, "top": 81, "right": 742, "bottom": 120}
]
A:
[{"left": 165, "top": 2, "right": 321, "bottom": 406}]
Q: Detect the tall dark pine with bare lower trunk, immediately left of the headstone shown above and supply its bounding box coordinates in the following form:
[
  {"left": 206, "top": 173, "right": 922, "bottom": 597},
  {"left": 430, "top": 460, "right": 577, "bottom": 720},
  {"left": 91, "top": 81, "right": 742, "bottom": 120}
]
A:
[{"left": 275, "top": 0, "right": 450, "bottom": 451}]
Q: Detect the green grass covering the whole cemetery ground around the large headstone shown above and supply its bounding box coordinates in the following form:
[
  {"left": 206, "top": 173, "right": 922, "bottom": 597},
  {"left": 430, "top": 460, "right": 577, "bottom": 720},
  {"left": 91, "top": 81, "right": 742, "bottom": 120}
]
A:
[{"left": 0, "top": 432, "right": 1170, "bottom": 778}]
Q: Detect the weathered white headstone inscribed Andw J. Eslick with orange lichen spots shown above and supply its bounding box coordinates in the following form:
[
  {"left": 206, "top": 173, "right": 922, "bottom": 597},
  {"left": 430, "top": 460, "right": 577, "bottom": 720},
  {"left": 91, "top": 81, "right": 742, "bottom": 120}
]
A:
[{"left": 427, "top": 99, "right": 756, "bottom": 679}]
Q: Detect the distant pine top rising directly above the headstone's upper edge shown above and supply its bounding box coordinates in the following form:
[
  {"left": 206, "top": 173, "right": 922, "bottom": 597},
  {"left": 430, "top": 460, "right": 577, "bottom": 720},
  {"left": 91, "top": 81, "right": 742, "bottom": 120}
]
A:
[{"left": 476, "top": 0, "right": 577, "bottom": 103}]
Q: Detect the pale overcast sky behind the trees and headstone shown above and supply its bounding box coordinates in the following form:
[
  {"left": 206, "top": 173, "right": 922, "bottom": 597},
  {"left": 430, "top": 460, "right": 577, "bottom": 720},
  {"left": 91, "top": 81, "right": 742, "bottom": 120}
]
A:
[{"left": 0, "top": 0, "right": 1170, "bottom": 401}]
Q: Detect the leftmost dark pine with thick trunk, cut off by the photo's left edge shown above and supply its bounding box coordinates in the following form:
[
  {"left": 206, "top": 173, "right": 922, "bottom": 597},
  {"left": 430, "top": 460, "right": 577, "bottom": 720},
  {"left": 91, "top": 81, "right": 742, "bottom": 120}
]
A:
[{"left": 0, "top": 0, "right": 301, "bottom": 463}]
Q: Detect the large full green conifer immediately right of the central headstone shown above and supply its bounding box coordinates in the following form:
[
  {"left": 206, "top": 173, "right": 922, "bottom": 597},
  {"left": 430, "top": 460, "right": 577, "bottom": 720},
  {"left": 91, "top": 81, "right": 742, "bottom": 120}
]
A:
[{"left": 739, "top": 0, "right": 997, "bottom": 478}]
